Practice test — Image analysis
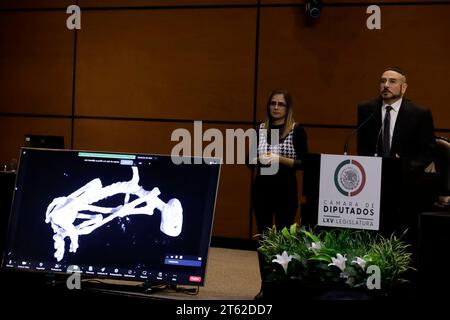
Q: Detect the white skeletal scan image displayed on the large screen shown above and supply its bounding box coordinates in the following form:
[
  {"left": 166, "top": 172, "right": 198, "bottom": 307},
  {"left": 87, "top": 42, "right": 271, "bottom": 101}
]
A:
[{"left": 45, "top": 167, "right": 183, "bottom": 261}]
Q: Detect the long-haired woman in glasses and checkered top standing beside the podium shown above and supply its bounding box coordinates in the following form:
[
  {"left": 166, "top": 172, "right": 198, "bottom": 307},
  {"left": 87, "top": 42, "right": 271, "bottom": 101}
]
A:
[{"left": 253, "top": 90, "right": 308, "bottom": 233}]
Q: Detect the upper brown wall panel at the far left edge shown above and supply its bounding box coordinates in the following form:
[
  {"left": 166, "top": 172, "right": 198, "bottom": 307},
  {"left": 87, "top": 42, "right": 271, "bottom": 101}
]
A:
[{"left": 0, "top": 11, "right": 74, "bottom": 115}]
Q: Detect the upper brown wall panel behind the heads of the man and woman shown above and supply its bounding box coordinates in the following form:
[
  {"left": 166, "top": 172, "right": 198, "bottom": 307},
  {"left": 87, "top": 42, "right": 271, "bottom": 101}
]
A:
[{"left": 257, "top": 6, "right": 450, "bottom": 127}]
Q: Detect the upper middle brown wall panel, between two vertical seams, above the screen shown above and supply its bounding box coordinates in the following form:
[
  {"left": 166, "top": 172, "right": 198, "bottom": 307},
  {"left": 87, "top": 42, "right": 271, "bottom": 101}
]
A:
[{"left": 76, "top": 9, "right": 256, "bottom": 121}]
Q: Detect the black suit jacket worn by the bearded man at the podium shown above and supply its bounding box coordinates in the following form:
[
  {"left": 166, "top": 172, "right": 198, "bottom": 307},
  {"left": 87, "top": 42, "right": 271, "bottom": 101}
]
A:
[{"left": 357, "top": 97, "right": 435, "bottom": 168}]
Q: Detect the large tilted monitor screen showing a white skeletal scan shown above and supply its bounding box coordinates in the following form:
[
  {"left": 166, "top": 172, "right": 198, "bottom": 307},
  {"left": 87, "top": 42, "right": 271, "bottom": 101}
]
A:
[{"left": 2, "top": 148, "right": 220, "bottom": 286}]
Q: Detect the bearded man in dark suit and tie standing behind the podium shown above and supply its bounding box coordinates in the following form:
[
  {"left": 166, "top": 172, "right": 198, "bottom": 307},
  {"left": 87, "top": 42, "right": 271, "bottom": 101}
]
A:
[{"left": 357, "top": 67, "right": 435, "bottom": 169}]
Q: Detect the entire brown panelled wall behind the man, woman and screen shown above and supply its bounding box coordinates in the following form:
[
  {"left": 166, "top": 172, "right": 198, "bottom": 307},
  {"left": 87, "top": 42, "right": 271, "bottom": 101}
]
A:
[{"left": 0, "top": 0, "right": 450, "bottom": 239}]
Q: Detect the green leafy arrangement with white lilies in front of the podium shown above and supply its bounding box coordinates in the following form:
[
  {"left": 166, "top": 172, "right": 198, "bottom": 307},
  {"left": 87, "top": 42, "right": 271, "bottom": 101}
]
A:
[{"left": 258, "top": 224, "right": 414, "bottom": 290}]
